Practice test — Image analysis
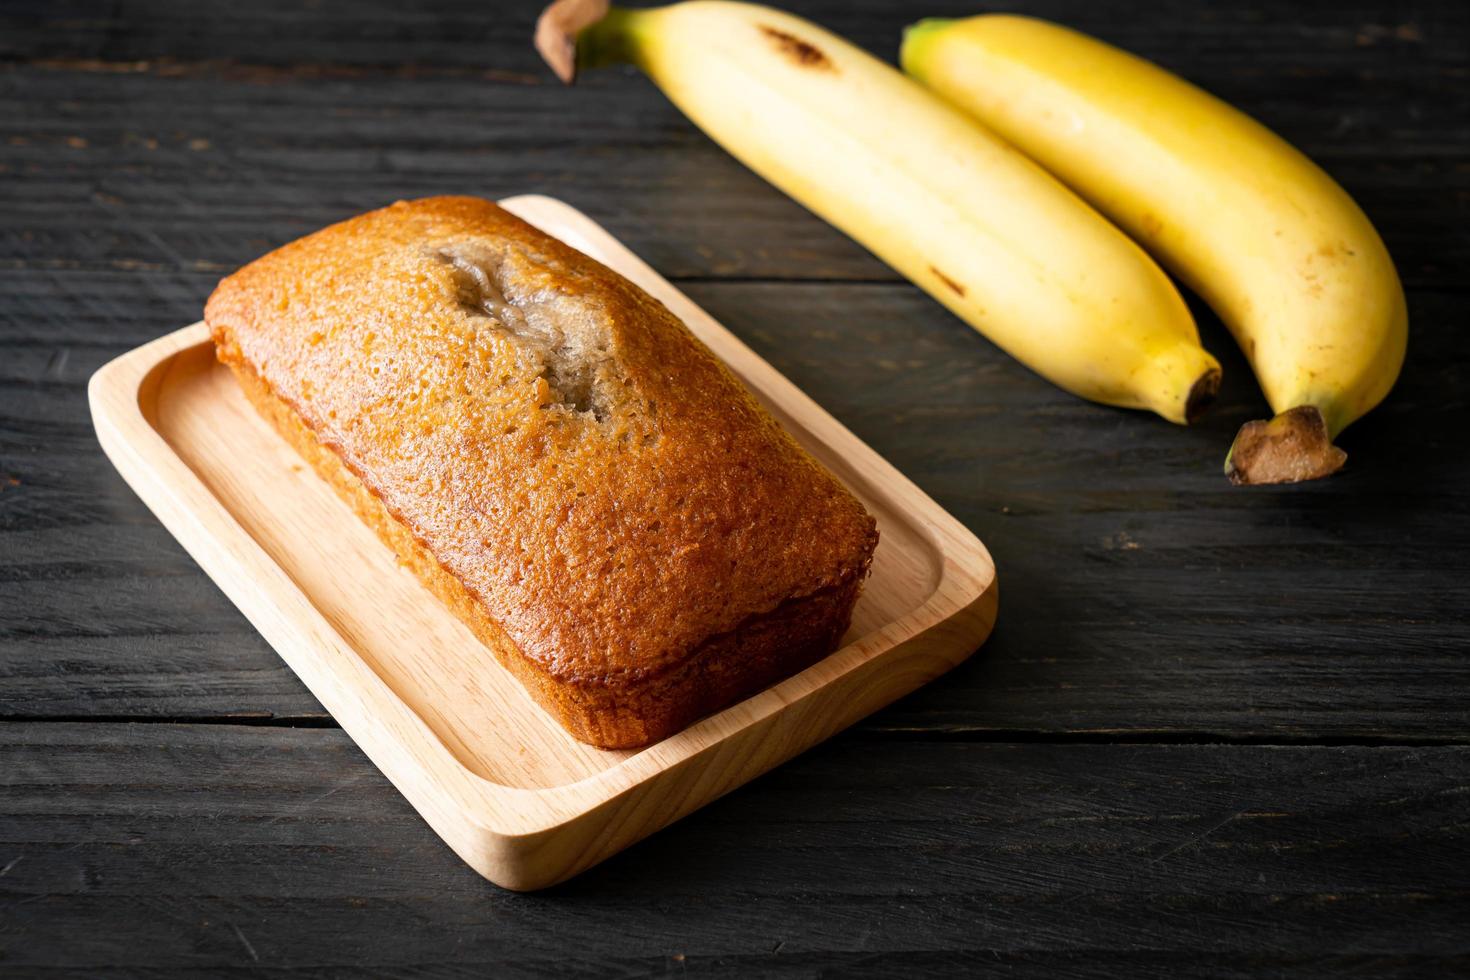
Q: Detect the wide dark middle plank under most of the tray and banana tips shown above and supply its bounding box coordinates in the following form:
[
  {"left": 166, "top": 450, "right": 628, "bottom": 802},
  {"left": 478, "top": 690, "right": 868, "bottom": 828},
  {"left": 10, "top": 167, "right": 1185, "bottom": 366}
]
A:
[{"left": 0, "top": 270, "right": 1470, "bottom": 741}]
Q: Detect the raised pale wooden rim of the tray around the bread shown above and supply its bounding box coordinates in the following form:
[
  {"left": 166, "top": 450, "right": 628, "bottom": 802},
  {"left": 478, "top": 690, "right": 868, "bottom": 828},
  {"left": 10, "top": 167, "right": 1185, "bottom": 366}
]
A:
[{"left": 88, "top": 195, "right": 995, "bottom": 887}]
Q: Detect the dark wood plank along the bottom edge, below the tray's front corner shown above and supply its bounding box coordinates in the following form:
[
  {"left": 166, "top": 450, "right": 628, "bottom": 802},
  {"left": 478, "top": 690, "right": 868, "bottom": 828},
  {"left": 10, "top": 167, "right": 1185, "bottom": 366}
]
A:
[{"left": 0, "top": 723, "right": 1470, "bottom": 977}]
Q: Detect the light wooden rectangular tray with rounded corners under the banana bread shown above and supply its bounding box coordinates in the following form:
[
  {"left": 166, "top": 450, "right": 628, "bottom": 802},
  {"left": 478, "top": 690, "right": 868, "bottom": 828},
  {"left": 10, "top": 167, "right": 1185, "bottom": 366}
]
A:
[{"left": 88, "top": 197, "right": 997, "bottom": 889}]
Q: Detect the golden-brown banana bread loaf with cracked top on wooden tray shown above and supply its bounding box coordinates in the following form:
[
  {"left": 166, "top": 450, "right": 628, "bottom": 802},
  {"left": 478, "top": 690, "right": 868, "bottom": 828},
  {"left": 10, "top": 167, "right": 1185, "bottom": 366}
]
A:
[{"left": 204, "top": 197, "right": 878, "bottom": 748}]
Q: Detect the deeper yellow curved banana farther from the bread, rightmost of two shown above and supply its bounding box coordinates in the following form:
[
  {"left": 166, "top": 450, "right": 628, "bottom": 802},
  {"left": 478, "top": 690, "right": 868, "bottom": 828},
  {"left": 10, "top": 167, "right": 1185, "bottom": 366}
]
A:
[{"left": 900, "top": 15, "right": 1408, "bottom": 483}]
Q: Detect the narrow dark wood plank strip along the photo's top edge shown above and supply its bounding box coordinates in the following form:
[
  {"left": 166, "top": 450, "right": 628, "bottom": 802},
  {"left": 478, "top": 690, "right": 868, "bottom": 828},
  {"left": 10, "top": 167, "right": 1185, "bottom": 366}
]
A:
[{"left": 0, "top": 0, "right": 1470, "bottom": 79}]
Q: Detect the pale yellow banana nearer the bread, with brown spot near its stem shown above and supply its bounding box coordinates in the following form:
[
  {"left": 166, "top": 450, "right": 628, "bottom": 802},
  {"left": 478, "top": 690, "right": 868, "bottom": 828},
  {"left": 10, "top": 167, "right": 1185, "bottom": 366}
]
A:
[{"left": 537, "top": 0, "right": 1220, "bottom": 422}]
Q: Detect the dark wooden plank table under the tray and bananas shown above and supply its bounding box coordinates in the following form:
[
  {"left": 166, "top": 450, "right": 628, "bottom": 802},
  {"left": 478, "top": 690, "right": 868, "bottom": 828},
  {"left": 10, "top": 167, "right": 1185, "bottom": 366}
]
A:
[{"left": 0, "top": 0, "right": 1470, "bottom": 977}]
